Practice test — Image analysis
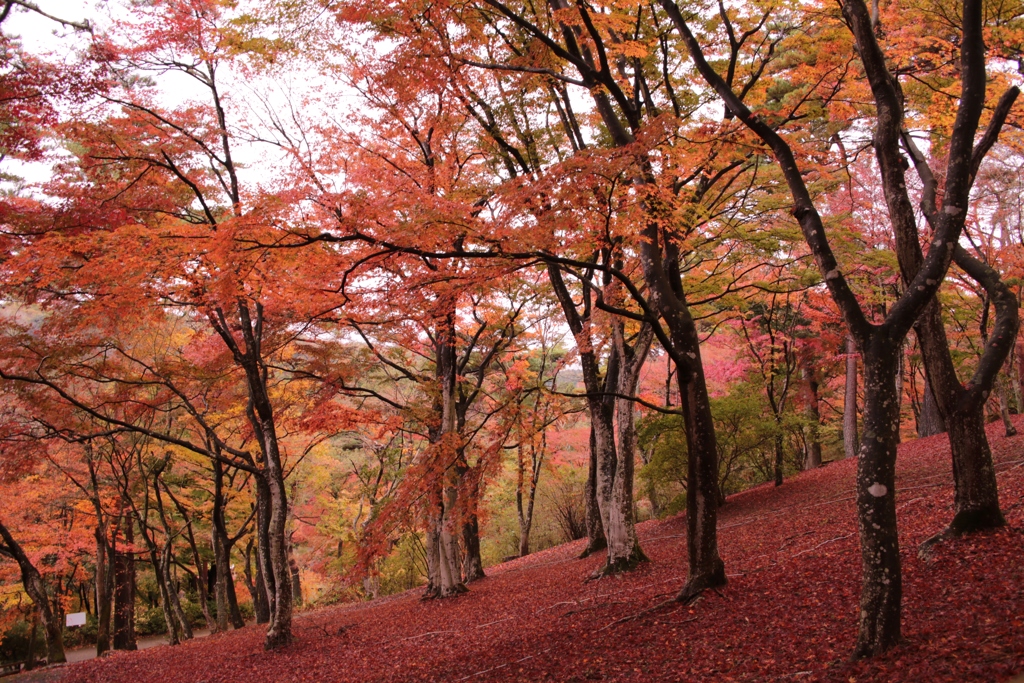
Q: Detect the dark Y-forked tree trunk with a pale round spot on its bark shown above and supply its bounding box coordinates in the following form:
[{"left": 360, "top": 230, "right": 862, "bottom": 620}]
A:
[{"left": 660, "top": 0, "right": 1017, "bottom": 656}]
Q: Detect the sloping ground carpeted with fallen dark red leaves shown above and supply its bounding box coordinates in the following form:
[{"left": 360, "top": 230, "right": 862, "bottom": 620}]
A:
[{"left": 25, "top": 417, "right": 1024, "bottom": 683}]
